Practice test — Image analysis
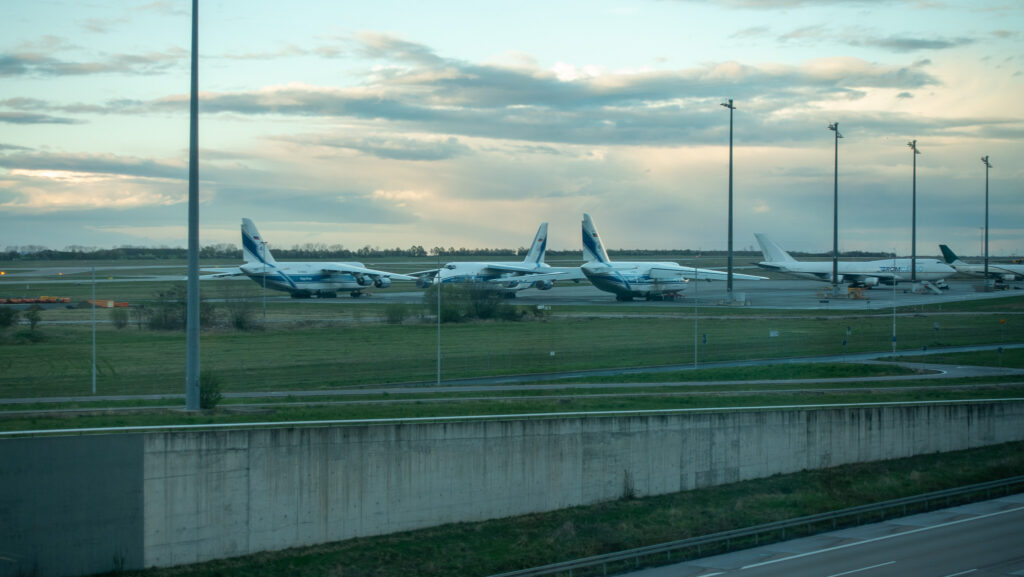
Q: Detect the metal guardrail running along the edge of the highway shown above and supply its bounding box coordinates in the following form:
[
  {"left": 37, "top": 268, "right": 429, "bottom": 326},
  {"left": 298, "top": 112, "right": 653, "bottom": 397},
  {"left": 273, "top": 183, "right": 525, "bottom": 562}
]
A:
[{"left": 490, "top": 476, "right": 1024, "bottom": 577}]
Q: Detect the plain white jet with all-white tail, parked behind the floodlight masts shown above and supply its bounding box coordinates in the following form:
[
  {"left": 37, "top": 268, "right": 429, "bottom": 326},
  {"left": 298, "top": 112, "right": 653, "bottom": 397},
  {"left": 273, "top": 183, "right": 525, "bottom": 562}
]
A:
[{"left": 754, "top": 233, "right": 956, "bottom": 287}]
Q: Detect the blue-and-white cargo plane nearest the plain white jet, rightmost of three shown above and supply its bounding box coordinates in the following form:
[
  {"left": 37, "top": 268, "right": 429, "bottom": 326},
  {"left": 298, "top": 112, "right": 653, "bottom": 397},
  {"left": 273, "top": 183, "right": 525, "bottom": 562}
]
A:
[{"left": 582, "top": 213, "right": 764, "bottom": 300}]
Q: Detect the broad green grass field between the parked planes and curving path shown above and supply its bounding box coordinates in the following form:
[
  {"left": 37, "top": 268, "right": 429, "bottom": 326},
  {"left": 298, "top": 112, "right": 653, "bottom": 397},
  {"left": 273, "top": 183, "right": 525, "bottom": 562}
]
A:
[{"left": 0, "top": 306, "right": 1024, "bottom": 398}]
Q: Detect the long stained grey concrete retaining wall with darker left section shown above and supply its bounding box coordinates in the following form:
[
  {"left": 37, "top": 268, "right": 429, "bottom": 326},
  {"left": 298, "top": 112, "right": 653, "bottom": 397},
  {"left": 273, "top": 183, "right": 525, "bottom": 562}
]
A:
[{"left": 0, "top": 403, "right": 1024, "bottom": 576}]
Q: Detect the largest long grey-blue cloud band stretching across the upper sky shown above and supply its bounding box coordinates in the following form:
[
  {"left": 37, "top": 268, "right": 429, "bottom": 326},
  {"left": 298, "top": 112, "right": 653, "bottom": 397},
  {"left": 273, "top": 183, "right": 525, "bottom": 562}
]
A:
[{"left": 99, "top": 34, "right": 940, "bottom": 148}]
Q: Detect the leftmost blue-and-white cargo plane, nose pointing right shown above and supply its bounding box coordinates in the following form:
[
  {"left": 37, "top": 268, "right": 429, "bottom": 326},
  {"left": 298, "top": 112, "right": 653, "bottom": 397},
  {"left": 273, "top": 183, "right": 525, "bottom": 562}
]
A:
[{"left": 203, "top": 218, "right": 416, "bottom": 298}]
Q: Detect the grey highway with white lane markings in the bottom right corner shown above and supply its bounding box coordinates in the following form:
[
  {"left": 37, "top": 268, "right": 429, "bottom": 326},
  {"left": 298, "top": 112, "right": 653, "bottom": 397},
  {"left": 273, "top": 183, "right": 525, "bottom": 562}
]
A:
[{"left": 627, "top": 494, "right": 1024, "bottom": 577}]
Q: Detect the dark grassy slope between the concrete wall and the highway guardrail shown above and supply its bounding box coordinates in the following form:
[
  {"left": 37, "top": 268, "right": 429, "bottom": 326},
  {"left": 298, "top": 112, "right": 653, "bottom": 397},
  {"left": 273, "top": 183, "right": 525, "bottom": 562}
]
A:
[{"left": 112, "top": 443, "right": 1024, "bottom": 577}]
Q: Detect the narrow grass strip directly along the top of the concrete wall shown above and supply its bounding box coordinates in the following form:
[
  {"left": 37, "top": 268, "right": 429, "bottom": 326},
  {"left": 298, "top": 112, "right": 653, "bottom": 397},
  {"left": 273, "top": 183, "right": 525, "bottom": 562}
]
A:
[{"left": 8, "top": 378, "right": 1024, "bottom": 430}]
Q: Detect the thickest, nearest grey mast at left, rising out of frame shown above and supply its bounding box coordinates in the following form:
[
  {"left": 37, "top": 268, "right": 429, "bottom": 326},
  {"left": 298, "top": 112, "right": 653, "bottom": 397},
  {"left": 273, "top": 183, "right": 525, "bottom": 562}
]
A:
[{"left": 185, "top": 0, "right": 200, "bottom": 411}]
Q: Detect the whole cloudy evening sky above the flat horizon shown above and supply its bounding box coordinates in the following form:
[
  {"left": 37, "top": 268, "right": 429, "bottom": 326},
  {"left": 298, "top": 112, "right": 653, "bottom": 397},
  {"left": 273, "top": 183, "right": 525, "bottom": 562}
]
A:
[{"left": 0, "top": 0, "right": 1024, "bottom": 255}]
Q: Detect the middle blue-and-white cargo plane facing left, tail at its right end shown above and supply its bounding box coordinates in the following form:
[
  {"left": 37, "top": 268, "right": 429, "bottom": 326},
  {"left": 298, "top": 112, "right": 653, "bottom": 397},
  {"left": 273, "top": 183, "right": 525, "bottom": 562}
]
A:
[{"left": 412, "top": 222, "right": 584, "bottom": 297}]
